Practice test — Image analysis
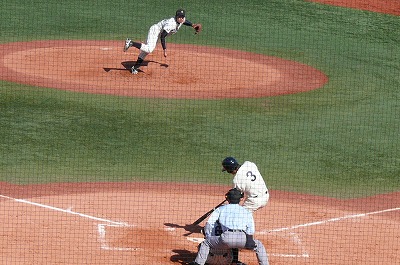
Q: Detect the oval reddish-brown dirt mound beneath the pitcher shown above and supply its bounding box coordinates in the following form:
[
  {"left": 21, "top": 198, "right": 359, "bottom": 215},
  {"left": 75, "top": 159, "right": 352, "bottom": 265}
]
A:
[{"left": 0, "top": 41, "right": 328, "bottom": 99}]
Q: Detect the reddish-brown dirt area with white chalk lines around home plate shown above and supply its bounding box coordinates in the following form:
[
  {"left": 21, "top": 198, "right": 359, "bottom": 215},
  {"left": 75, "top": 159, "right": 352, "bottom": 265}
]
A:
[{"left": 0, "top": 183, "right": 400, "bottom": 265}]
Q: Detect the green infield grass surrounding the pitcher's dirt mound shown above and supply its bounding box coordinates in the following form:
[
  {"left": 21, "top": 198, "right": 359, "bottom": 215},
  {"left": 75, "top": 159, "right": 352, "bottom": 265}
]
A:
[{"left": 0, "top": 0, "right": 400, "bottom": 198}]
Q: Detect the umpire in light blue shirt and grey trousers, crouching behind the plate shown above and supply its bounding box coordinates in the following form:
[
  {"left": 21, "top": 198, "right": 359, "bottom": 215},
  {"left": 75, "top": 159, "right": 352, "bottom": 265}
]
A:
[{"left": 189, "top": 189, "right": 269, "bottom": 265}]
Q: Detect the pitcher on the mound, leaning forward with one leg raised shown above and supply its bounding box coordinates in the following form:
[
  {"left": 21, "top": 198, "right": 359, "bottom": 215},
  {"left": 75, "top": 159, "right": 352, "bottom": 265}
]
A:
[{"left": 124, "top": 9, "right": 202, "bottom": 74}]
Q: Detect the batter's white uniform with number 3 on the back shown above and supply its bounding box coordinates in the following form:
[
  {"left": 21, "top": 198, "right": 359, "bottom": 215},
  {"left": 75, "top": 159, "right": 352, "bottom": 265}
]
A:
[{"left": 233, "top": 161, "right": 269, "bottom": 212}]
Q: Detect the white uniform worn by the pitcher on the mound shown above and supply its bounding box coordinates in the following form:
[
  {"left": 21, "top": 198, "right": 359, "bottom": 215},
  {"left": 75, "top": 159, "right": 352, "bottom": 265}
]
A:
[{"left": 139, "top": 17, "right": 183, "bottom": 59}]
